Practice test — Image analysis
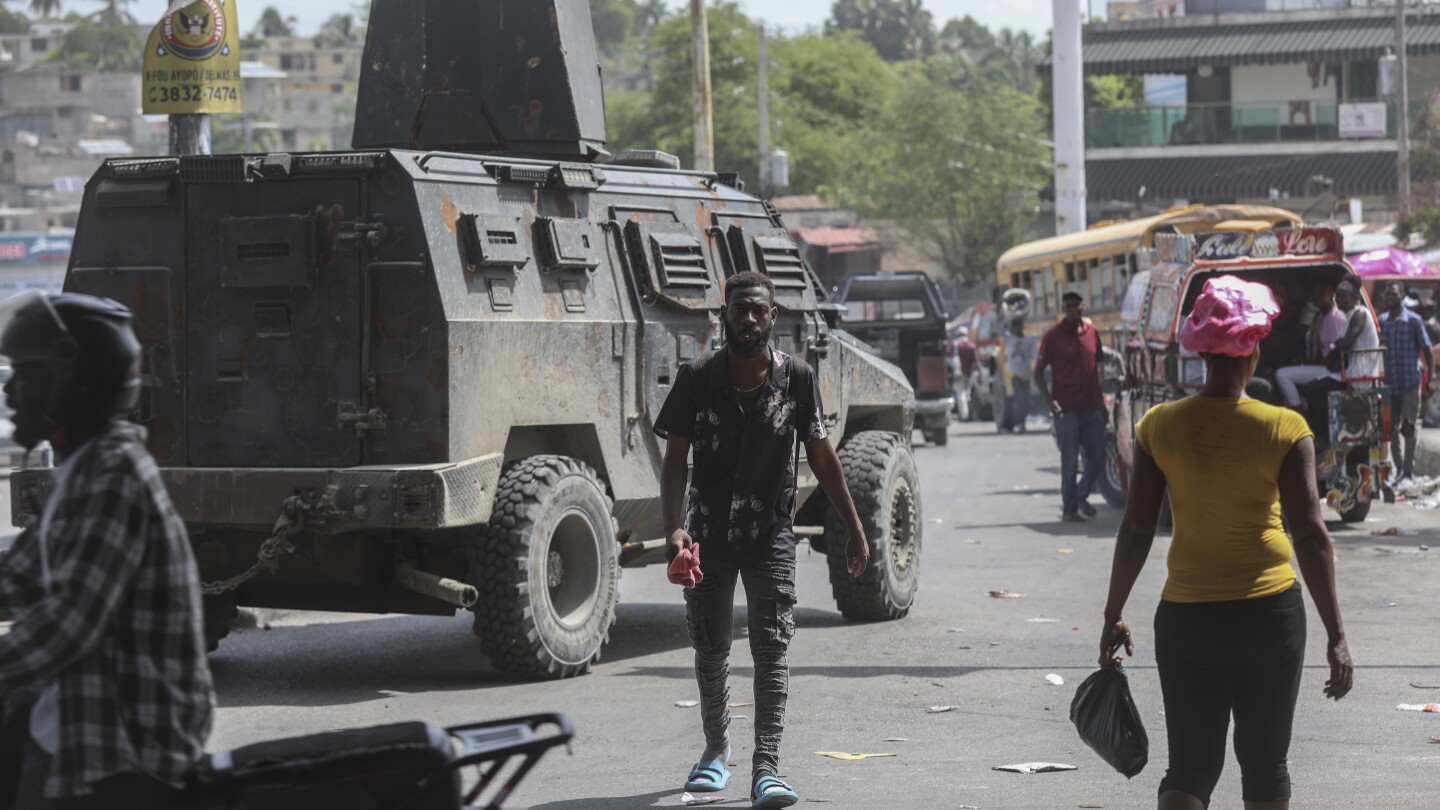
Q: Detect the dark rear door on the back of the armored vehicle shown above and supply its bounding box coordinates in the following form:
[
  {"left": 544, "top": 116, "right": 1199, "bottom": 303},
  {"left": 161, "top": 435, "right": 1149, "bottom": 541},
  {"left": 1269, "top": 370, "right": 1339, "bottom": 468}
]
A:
[{"left": 184, "top": 179, "right": 364, "bottom": 467}]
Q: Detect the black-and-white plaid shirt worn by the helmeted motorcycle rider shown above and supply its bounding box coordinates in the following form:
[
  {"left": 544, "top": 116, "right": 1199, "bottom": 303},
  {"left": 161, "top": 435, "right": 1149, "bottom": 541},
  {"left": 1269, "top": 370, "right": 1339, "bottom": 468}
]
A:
[{"left": 0, "top": 421, "right": 215, "bottom": 798}]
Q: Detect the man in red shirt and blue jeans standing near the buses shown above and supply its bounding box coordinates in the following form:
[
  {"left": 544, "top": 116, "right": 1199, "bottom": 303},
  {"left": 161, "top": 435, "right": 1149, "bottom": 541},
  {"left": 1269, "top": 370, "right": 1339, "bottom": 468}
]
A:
[{"left": 1035, "top": 293, "right": 1106, "bottom": 523}]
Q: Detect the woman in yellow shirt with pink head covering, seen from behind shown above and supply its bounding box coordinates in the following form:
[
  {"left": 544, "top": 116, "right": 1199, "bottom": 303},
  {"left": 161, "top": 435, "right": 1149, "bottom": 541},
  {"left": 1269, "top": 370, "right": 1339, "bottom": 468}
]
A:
[{"left": 1100, "top": 275, "right": 1354, "bottom": 810}]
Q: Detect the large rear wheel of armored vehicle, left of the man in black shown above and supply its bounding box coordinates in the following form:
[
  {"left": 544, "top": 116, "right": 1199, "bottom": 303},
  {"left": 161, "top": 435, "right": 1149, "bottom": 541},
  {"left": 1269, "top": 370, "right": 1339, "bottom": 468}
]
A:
[{"left": 468, "top": 455, "right": 621, "bottom": 679}]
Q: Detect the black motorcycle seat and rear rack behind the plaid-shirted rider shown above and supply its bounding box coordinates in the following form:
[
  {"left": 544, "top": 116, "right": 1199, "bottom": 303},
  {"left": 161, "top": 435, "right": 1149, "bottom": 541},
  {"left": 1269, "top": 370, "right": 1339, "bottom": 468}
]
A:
[{"left": 164, "top": 713, "right": 575, "bottom": 810}]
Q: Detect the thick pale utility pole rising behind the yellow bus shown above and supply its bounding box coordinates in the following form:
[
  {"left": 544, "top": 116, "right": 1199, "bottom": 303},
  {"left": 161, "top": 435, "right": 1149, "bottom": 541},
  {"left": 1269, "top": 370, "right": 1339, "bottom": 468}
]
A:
[{"left": 1051, "top": 0, "right": 1086, "bottom": 233}]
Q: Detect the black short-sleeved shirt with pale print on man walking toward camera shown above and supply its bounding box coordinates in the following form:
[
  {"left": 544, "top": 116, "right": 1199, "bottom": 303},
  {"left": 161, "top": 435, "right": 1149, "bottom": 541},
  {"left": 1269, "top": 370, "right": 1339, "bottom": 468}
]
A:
[{"left": 655, "top": 347, "right": 829, "bottom": 568}]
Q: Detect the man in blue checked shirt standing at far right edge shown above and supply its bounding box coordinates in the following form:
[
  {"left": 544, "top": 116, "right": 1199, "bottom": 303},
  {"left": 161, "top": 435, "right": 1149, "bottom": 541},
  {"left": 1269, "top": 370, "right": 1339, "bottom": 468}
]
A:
[{"left": 1380, "top": 281, "right": 1434, "bottom": 483}]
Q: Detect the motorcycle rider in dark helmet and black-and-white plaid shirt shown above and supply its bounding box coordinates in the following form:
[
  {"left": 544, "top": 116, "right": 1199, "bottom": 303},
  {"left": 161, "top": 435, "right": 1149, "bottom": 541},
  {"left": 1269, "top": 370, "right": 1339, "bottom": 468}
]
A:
[{"left": 0, "top": 293, "right": 215, "bottom": 809}]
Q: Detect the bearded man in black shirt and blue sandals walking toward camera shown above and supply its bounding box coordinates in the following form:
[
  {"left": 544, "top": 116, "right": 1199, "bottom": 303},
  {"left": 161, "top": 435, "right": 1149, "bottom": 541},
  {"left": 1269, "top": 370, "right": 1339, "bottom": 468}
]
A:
[{"left": 655, "top": 272, "right": 870, "bottom": 809}]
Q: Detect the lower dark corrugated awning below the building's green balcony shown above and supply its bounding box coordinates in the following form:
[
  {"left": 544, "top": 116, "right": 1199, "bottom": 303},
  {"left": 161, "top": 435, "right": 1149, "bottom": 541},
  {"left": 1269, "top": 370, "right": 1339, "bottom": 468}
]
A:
[{"left": 1084, "top": 151, "right": 1418, "bottom": 205}]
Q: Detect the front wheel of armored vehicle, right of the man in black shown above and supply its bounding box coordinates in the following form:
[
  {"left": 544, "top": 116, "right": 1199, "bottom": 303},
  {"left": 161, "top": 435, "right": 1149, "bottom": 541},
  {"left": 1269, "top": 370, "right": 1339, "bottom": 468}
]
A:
[{"left": 825, "top": 431, "right": 923, "bottom": 621}]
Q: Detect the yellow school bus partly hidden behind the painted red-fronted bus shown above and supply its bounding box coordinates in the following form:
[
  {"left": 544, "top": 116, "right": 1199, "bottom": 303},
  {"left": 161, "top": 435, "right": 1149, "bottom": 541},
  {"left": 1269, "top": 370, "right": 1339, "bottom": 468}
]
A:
[{"left": 995, "top": 205, "right": 1300, "bottom": 336}]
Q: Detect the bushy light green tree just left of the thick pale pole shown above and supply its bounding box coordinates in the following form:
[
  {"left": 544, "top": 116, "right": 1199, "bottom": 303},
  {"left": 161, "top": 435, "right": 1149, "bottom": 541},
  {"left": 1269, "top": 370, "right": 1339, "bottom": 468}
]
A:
[{"left": 838, "top": 61, "right": 1050, "bottom": 282}]
